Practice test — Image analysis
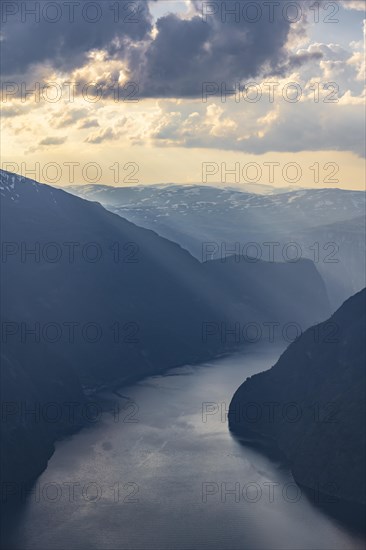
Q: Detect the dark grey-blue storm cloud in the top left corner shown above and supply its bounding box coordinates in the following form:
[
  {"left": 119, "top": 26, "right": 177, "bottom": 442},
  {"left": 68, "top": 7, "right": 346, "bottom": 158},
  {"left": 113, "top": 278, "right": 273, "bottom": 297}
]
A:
[{"left": 1, "top": 0, "right": 152, "bottom": 75}]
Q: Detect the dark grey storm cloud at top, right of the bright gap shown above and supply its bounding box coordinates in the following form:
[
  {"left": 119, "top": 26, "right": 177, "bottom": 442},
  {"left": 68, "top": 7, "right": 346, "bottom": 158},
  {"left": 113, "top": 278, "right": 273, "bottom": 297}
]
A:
[{"left": 121, "top": 0, "right": 321, "bottom": 97}]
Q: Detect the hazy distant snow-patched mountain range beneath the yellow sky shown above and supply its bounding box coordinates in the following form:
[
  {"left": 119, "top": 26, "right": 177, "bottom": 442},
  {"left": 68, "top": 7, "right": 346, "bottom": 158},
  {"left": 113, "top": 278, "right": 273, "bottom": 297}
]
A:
[{"left": 67, "top": 185, "right": 365, "bottom": 309}]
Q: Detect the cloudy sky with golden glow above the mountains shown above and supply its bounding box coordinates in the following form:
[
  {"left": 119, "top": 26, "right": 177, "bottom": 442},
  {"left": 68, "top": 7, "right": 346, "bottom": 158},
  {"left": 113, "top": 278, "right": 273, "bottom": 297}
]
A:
[{"left": 1, "top": 0, "right": 366, "bottom": 189}]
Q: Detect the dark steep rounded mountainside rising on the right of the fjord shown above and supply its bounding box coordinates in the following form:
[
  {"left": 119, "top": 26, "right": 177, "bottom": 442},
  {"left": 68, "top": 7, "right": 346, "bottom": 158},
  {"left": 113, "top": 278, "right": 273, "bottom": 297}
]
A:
[{"left": 229, "top": 290, "right": 366, "bottom": 505}]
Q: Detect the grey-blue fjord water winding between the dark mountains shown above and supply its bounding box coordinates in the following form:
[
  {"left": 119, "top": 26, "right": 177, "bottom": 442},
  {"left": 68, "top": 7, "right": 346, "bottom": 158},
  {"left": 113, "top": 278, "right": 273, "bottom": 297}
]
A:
[{"left": 4, "top": 349, "right": 365, "bottom": 550}]
